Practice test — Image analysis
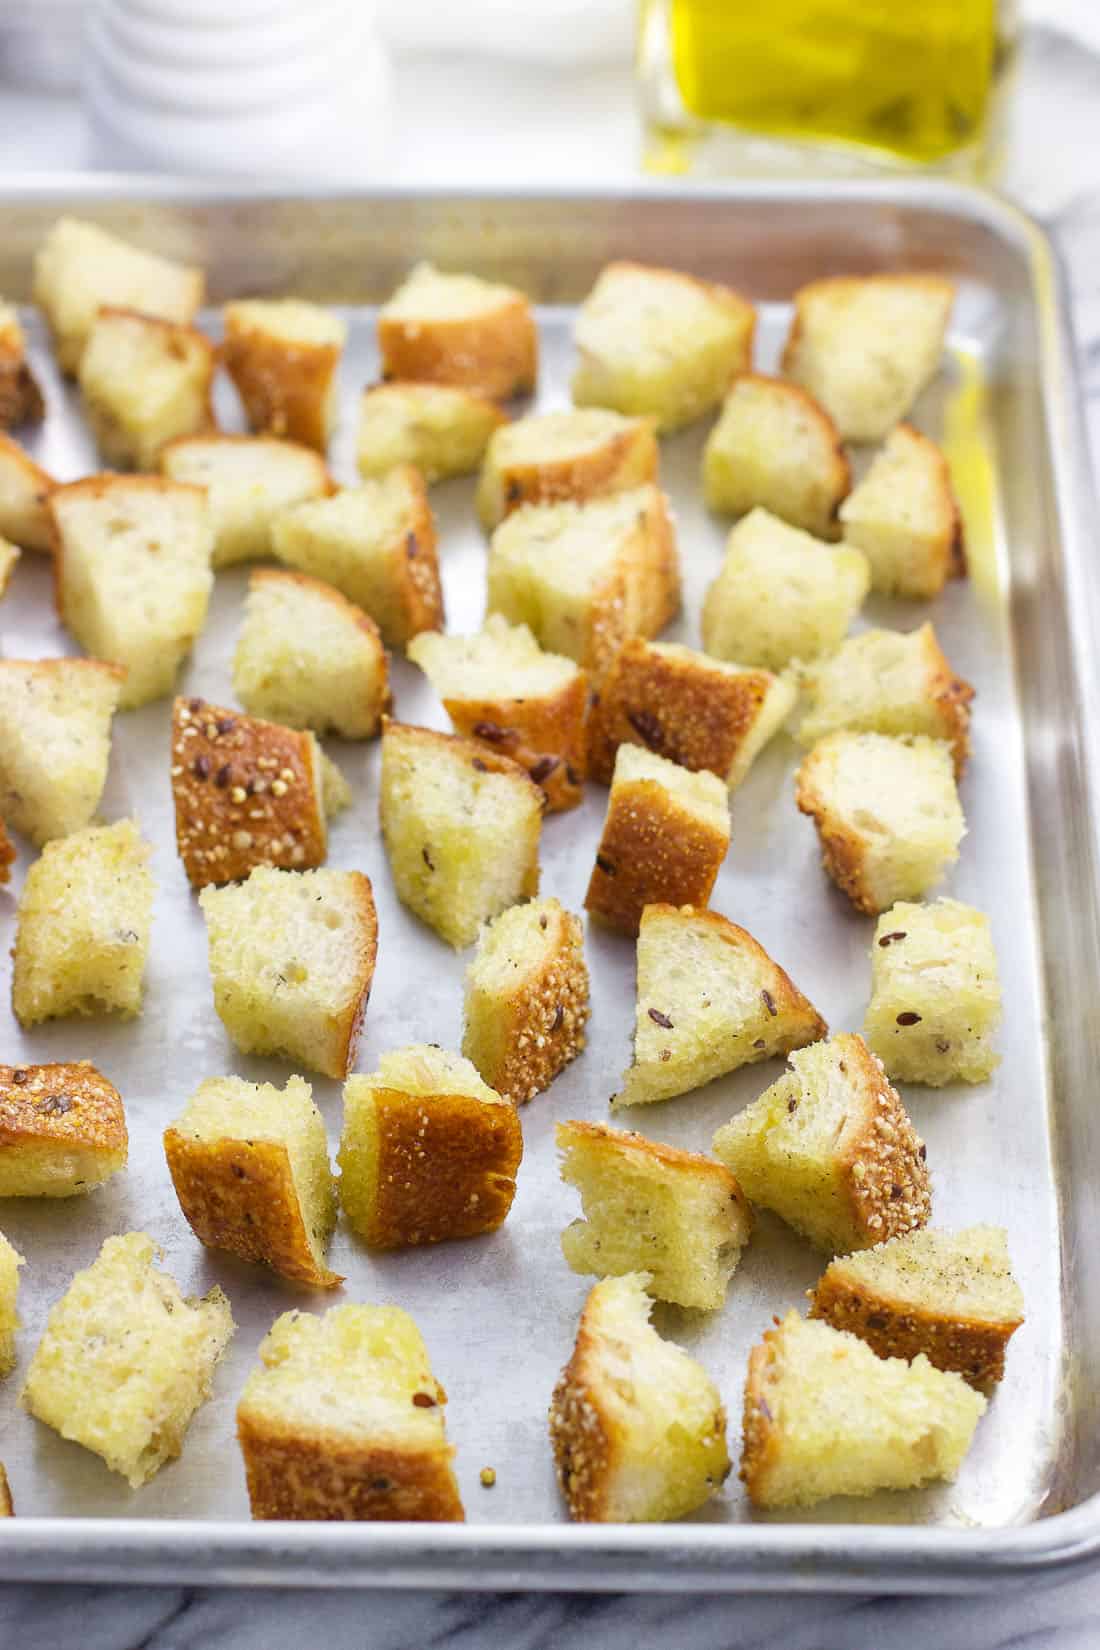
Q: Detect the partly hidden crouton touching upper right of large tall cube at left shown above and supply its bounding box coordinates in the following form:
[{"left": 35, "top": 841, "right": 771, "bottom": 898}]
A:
[{"left": 160, "top": 434, "right": 333, "bottom": 568}]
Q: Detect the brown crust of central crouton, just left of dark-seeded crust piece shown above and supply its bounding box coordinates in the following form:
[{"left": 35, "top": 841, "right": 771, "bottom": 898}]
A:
[{"left": 444, "top": 670, "right": 589, "bottom": 813}]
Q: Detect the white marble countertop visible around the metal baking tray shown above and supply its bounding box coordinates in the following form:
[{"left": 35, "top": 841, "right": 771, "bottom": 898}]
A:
[{"left": 0, "top": 12, "right": 1100, "bottom": 1650}]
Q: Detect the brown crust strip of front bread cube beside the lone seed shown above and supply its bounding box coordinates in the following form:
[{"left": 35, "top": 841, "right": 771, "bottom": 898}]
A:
[{"left": 237, "top": 1404, "right": 465, "bottom": 1523}]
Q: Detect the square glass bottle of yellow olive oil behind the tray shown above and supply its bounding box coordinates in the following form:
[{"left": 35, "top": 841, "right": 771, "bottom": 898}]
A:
[{"left": 638, "top": 0, "right": 1013, "bottom": 175}]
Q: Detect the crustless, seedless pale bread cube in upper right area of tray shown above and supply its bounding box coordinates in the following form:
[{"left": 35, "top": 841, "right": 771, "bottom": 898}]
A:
[{"left": 703, "top": 510, "right": 871, "bottom": 670}]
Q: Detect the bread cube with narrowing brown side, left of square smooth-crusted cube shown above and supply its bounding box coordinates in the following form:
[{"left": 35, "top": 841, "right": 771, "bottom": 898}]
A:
[{"left": 165, "top": 1077, "right": 343, "bottom": 1289}]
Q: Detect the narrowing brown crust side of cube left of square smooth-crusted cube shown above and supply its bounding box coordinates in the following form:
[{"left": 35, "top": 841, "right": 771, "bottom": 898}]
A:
[{"left": 165, "top": 1125, "right": 343, "bottom": 1289}]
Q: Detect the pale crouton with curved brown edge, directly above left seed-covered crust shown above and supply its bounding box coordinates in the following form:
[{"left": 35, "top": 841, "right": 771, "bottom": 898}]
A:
[{"left": 233, "top": 568, "right": 389, "bottom": 739}]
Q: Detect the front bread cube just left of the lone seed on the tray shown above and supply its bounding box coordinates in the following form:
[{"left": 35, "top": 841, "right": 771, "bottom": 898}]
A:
[{"left": 237, "top": 1305, "right": 463, "bottom": 1523}]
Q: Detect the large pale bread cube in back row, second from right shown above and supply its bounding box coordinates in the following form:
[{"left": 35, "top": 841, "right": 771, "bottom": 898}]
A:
[{"left": 572, "top": 262, "right": 757, "bottom": 431}]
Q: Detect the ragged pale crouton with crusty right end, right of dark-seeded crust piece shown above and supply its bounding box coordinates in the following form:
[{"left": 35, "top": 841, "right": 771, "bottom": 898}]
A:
[{"left": 798, "top": 624, "right": 975, "bottom": 777}]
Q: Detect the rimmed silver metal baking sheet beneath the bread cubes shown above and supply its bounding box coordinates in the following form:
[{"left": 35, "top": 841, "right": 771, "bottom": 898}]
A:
[{"left": 0, "top": 178, "right": 1100, "bottom": 1589}]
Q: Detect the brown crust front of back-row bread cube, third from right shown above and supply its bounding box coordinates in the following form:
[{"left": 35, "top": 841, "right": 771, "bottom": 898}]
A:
[{"left": 378, "top": 292, "right": 539, "bottom": 401}]
